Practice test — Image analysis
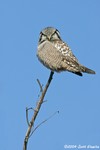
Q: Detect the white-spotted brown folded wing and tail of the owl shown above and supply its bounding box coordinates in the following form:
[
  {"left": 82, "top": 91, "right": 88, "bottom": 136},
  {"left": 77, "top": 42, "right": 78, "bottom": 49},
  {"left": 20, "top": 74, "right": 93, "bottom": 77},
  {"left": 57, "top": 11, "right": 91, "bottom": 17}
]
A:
[{"left": 55, "top": 41, "right": 95, "bottom": 76}]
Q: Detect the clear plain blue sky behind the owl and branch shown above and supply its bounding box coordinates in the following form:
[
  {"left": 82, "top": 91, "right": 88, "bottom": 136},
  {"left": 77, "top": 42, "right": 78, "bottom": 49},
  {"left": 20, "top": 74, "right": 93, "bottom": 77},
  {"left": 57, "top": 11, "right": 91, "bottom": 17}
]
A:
[{"left": 0, "top": 0, "right": 100, "bottom": 150}]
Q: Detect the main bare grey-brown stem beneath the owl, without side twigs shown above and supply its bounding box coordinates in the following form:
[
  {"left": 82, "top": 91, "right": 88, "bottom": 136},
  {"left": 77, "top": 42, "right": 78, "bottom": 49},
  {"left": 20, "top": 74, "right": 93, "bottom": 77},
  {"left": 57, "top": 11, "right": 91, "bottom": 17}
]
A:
[{"left": 23, "top": 71, "right": 54, "bottom": 150}]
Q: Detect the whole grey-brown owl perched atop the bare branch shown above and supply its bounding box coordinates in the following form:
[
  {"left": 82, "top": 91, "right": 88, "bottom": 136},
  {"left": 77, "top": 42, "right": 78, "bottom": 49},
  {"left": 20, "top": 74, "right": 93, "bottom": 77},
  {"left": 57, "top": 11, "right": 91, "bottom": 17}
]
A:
[{"left": 37, "top": 27, "right": 95, "bottom": 76}]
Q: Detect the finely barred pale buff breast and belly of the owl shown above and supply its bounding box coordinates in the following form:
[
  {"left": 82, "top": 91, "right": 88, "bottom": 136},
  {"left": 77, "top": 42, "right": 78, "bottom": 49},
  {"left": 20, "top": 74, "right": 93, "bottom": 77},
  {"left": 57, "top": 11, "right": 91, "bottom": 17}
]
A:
[{"left": 37, "top": 41, "right": 66, "bottom": 72}]
